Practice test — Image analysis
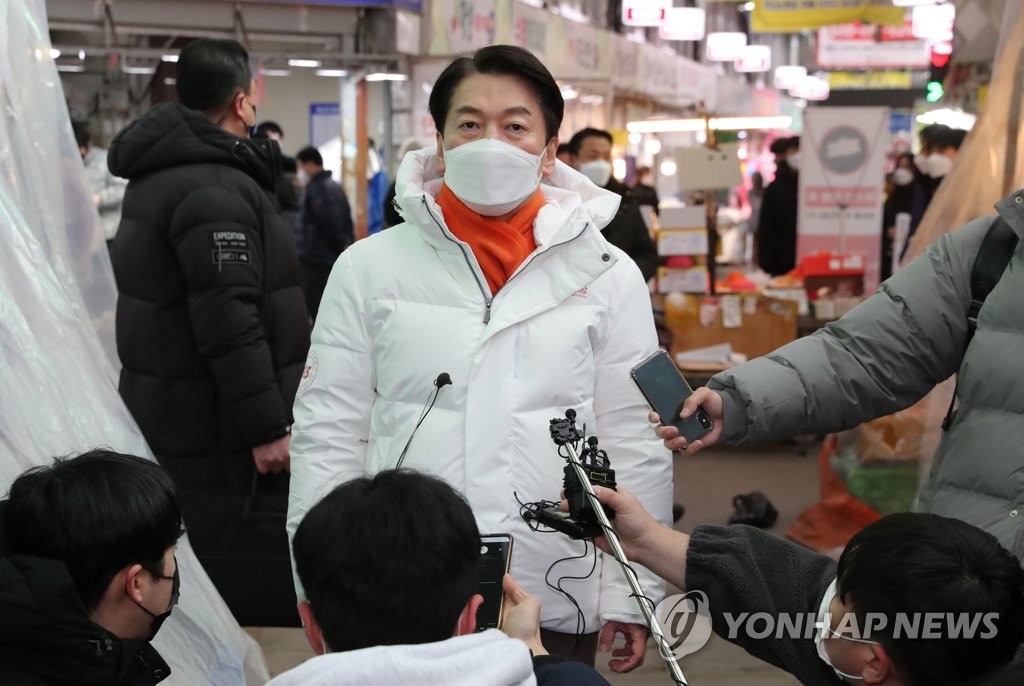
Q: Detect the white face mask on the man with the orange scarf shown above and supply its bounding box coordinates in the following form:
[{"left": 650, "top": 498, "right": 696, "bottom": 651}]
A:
[{"left": 444, "top": 138, "right": 548, "bottom": 217}]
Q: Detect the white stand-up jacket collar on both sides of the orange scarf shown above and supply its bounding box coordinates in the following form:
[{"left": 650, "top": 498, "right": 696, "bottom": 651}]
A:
[{"left": 395, "top": 146, "right": 622, "bottom": 250}]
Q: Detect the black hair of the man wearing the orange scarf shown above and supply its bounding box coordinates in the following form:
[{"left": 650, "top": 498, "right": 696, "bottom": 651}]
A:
[{"left": 429, "top": 45, "right": 565, "bottom": 140}]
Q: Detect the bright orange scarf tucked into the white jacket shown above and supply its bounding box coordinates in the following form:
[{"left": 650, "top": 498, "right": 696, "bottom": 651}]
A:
[{"left": 437, "top": 185, "right": 546, "bottom": 295}]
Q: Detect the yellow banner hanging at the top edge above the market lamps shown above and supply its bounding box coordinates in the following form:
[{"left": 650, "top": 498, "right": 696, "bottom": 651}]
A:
[{"left": 752, "top": 0, "right": 906, "bottom": 33}]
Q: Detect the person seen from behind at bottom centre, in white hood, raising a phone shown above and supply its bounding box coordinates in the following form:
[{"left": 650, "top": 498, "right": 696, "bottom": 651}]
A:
[{"left": 270, "top": 470, "right": 607, "bottom": 686}]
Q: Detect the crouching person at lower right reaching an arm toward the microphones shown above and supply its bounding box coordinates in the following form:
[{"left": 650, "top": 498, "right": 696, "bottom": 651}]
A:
[{"left": 562, "top": 481, "right": 1024, "bottom": 686}]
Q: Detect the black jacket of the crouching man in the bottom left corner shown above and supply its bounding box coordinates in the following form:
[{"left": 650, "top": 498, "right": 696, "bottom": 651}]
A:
[{"left": 0, "top": 502, "right": 171, "bottom": 686}]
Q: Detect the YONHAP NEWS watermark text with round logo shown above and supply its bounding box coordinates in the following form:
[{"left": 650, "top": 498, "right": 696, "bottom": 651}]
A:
[{"left": 655, "top": 591, "right": 999, "bottom": 658}]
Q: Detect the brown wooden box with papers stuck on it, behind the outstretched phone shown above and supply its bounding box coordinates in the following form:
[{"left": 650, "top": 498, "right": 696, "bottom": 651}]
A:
[{"left": 663, "top": 295, "right": 798, "bottom": 358}]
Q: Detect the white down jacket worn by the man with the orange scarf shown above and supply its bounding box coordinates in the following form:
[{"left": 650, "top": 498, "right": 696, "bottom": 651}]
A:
[{"left": 288, "top": 148, "right": 672, "bottom": 633}]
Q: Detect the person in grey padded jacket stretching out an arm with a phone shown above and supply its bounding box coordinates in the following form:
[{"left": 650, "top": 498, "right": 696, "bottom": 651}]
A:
[{"left": 652, "top": 189, "right": 1024, "bottom": 557}]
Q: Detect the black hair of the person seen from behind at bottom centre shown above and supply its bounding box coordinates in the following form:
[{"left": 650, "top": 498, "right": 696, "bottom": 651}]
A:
[{"left": 293, "top": 470, "right": 480, "bottom": 652}]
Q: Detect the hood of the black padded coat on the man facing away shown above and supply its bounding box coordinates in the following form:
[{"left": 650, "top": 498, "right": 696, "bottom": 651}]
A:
[{"left": 106, "top": 102, "right": 281, "bottom": 190}]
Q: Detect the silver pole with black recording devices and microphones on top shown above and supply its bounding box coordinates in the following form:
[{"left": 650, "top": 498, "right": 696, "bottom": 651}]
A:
[{"left": 522, "top": 410, "right": 687, "bottom": 686}]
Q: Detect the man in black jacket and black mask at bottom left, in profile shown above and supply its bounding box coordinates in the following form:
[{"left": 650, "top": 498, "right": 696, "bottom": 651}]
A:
[{"left": 0, "top": 451, "right": 183, "bottom": 686}]
